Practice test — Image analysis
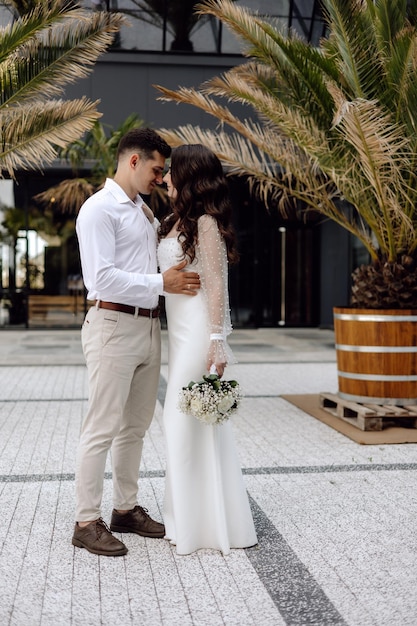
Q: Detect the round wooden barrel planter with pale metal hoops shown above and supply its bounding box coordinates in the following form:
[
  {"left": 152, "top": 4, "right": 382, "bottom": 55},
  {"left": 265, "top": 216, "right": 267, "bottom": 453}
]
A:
[{"left": 333, "top": 307, "right": 417, "bottom": 406}]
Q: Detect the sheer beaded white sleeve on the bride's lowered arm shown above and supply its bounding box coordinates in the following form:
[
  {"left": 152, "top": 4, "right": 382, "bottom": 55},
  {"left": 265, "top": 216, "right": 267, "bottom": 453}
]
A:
[{"left": 198, "top": 215, "right": 236, "bottom": 373}]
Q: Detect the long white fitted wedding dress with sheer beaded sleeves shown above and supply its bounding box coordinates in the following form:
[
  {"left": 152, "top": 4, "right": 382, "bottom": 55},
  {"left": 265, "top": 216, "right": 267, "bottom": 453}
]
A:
[{"left": 158, "top": 215, "right": 257, "bottom": 554}]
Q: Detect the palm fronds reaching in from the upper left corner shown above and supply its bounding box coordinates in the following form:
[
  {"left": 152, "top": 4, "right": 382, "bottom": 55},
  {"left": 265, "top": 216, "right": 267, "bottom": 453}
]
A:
[{"left": 0, "top": 0, "right": 125, "bottom": 177}]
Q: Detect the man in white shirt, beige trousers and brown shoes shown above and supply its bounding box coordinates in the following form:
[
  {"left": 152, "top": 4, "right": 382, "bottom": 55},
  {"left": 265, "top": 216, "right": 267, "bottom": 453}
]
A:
[{"left": 72, "top": 128, "right": 200, "bottom": 556}]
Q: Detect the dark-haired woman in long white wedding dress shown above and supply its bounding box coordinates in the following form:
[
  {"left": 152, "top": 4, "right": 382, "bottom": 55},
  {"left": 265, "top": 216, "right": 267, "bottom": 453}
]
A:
[{"left": 158, "top": 145, "right": 257, "bottom": 554}]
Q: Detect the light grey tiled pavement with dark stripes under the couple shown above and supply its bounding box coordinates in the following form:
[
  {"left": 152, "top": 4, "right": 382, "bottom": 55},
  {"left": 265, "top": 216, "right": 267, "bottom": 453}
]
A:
[{"left": 0, "top": 329, "right": 417, "bottom": 626}]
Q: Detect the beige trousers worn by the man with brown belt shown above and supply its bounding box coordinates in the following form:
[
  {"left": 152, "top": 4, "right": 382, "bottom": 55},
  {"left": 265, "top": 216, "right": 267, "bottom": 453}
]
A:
[{"left": 75, "top": 307, "right": 161, "bottom": 522}]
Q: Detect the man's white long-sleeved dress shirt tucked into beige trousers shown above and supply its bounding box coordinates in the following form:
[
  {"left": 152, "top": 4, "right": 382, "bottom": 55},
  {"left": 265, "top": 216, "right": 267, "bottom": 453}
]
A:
[{"left": 76, "top": 178, "right": 163, "bottom": 309}]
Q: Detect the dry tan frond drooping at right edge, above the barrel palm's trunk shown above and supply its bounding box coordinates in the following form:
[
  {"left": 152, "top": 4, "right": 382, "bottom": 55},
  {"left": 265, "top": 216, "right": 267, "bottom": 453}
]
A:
[{"left": 335, "top": 99, "right": 417, "bottom": 262}]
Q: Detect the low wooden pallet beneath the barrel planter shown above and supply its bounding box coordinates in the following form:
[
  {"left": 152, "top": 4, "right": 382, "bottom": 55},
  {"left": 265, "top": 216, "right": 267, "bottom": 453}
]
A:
[{"left": 319, "top": 393, "right": 417, "bottom": 430}]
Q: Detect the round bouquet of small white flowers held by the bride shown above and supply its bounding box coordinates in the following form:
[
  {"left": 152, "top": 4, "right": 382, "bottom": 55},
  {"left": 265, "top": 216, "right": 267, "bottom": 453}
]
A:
[{"left": 178, "top": 374, "right": 241, "bottom": 424}]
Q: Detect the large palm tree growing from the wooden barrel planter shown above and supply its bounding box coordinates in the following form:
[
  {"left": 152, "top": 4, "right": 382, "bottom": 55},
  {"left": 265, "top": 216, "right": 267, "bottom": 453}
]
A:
[{"left": 154, "top": 0, "right": 417, "bottom": 309}]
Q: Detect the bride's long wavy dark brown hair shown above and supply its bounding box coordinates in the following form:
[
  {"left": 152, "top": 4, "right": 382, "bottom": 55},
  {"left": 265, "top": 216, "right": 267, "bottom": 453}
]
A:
[{"left": 159, "top": 144, "right": 238, "bottom": 263}]
